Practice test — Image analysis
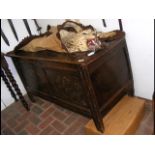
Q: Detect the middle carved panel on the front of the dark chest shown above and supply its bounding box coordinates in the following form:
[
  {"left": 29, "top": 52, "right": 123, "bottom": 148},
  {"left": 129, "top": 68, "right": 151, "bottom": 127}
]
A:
[{"left": 45, "top": 68, "right": 87, "bottom": 106}]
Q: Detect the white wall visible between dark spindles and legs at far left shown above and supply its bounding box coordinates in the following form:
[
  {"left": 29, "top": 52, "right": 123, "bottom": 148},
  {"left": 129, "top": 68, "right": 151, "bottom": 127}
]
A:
[{"left": 1, "top": 19, "right": 37, "bottom": 110}]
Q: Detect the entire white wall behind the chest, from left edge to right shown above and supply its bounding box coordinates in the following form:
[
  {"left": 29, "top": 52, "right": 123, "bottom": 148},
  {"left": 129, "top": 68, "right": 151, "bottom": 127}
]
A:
[{"left": 1, "top": 19, "right": 154, "bottom": 109}]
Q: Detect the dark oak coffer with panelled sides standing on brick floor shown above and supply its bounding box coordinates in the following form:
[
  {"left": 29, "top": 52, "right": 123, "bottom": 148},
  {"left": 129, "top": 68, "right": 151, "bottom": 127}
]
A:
[{"left": 7, "top": 36, "right": 134, "bottom": 132}]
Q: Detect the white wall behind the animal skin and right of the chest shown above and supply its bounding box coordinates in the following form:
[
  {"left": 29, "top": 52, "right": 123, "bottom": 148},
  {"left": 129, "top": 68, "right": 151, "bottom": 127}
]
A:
[{"left": 39, "top": 19, "right": 154, "bottom": 99}]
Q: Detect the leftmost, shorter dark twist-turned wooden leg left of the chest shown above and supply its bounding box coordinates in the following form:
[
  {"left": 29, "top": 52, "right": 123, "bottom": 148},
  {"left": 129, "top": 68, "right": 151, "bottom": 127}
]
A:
[{"left": 1, "top": 68, "right": 18, "bottom": 101}]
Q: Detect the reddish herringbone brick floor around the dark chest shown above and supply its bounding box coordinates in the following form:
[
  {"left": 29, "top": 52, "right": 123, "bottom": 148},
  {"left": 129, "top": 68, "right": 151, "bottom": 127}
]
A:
[{"left": 1, "top": 95, "right": 153, "bottom": 135}]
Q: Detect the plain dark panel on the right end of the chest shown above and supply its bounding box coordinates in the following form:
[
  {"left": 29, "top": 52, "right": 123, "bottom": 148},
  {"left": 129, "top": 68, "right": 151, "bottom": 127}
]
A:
[{"left": 90, "top": 42, "right": 130, "bottom": 107}]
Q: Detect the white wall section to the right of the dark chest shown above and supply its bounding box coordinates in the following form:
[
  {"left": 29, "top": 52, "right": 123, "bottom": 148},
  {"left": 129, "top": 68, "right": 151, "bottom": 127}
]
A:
[{"left": 124, "top": 19, "right": 154, "bottom": 99}]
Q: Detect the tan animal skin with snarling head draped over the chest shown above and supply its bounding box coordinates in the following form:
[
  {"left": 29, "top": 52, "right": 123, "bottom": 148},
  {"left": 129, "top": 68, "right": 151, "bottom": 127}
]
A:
[{"left": 15, "top": 20, "right": 123, "bottom": 53}]
